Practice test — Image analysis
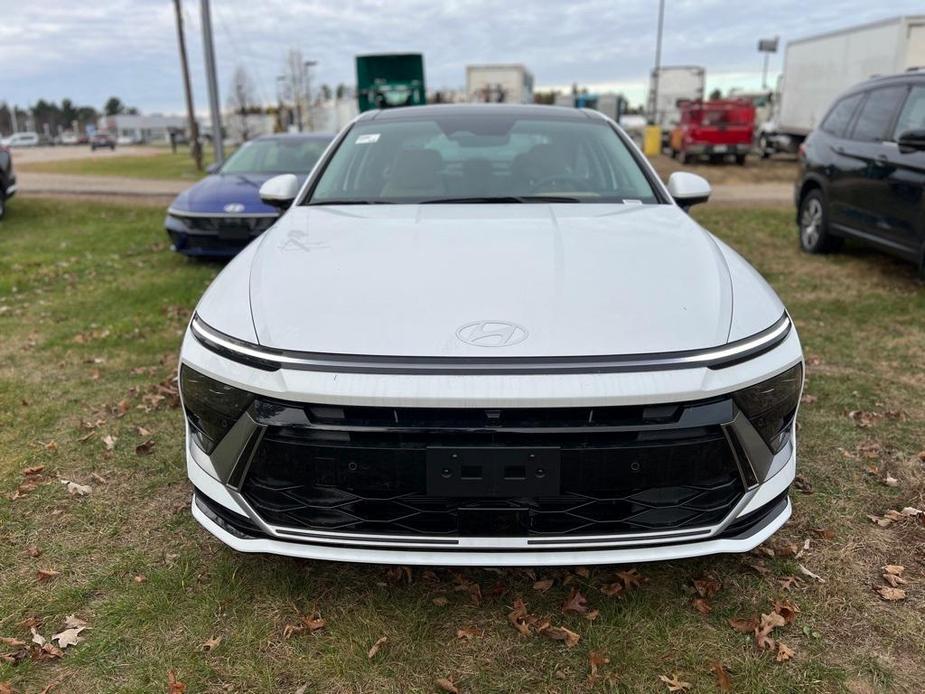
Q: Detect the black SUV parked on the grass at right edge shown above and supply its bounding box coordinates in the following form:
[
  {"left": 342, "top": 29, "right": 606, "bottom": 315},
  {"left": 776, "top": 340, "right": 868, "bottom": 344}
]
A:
[{"left": 795, "top": 72, "right": 925, "bottom": 276}]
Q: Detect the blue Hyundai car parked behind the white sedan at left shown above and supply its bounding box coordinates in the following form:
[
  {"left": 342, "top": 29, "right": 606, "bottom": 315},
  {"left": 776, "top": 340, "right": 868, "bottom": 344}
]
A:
[{"left": 164, "top": 133, "right": 334, "bottom": 258}]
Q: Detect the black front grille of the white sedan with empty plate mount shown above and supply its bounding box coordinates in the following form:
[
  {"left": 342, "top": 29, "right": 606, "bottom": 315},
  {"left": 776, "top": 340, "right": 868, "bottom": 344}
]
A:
[{"left": 235, "top": 400, "right": 745, "bottom": 538}]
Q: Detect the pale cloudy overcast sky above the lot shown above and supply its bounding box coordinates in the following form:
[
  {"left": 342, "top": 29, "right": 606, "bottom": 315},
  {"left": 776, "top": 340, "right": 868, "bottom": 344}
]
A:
[{"left": 0, "top": 0, "right": 925, "bottom": 113}]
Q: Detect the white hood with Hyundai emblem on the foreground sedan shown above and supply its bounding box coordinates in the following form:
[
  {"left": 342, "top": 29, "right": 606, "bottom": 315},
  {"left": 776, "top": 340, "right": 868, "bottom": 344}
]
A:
[{"left": 235, "top": 204, "right": 768, "bottom": 357}]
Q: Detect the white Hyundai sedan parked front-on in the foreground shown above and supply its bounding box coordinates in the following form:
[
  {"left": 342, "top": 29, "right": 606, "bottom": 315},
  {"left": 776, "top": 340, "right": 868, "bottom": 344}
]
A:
[{"left": 179, "top": 104, "right": 803, "bottom": 566}]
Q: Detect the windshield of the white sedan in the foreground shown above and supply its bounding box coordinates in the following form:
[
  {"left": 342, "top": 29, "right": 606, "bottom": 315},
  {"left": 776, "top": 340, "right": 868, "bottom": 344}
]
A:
[{"left": 308, "top": 109, "right": 659, "bottom": 205}]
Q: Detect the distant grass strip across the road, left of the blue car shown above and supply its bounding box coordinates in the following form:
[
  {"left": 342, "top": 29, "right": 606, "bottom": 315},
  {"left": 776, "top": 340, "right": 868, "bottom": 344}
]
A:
[{"left": 17, "top": 147, "right": 212, "bottom": 181}]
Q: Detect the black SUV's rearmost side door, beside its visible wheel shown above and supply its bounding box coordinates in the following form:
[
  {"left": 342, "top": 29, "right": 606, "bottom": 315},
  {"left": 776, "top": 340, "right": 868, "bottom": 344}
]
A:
[{"left": 807, "top": 92, "right": 865, "bottom": 228}]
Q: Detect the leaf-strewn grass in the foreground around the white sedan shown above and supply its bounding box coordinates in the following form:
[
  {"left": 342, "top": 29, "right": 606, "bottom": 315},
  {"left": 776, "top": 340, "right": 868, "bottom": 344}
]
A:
[{"left": 0, "top": 198, "right": 925, "bottom": 694}]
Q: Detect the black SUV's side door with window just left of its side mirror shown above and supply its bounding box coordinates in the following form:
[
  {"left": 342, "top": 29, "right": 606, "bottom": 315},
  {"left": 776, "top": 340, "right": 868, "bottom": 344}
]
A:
[{"left": 840, "top": 84, "right": 909, "bottom": 252}]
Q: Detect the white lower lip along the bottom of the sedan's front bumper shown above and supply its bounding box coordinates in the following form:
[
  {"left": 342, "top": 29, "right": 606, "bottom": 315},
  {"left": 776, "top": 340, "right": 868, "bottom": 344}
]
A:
[{"left": 191, "top": 499, "right": 792, "bottom": 567}]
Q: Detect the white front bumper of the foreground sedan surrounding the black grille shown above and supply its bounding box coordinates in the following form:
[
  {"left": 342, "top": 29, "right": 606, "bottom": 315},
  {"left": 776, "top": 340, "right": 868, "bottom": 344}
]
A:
[{"left": 181, "top": 316, "right": 801, "bottom": 565}]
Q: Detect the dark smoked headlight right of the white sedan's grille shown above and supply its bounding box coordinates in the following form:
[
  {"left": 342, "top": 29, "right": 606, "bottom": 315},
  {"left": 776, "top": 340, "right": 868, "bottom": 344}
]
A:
[{"left": 734, "top": 364, "right": 803, "bottom": 453}]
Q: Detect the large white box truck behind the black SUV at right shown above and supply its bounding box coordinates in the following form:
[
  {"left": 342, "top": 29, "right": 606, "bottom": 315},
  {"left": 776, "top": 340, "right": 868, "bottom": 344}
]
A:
[{"left": 758, "top": 15, "right": 925, "bottom": 155}]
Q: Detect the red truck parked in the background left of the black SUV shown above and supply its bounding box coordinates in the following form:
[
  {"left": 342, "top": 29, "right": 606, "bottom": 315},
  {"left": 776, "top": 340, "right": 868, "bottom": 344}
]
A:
[{"left": 671, "top": 99, "right": 755, "bottom": 164}]
